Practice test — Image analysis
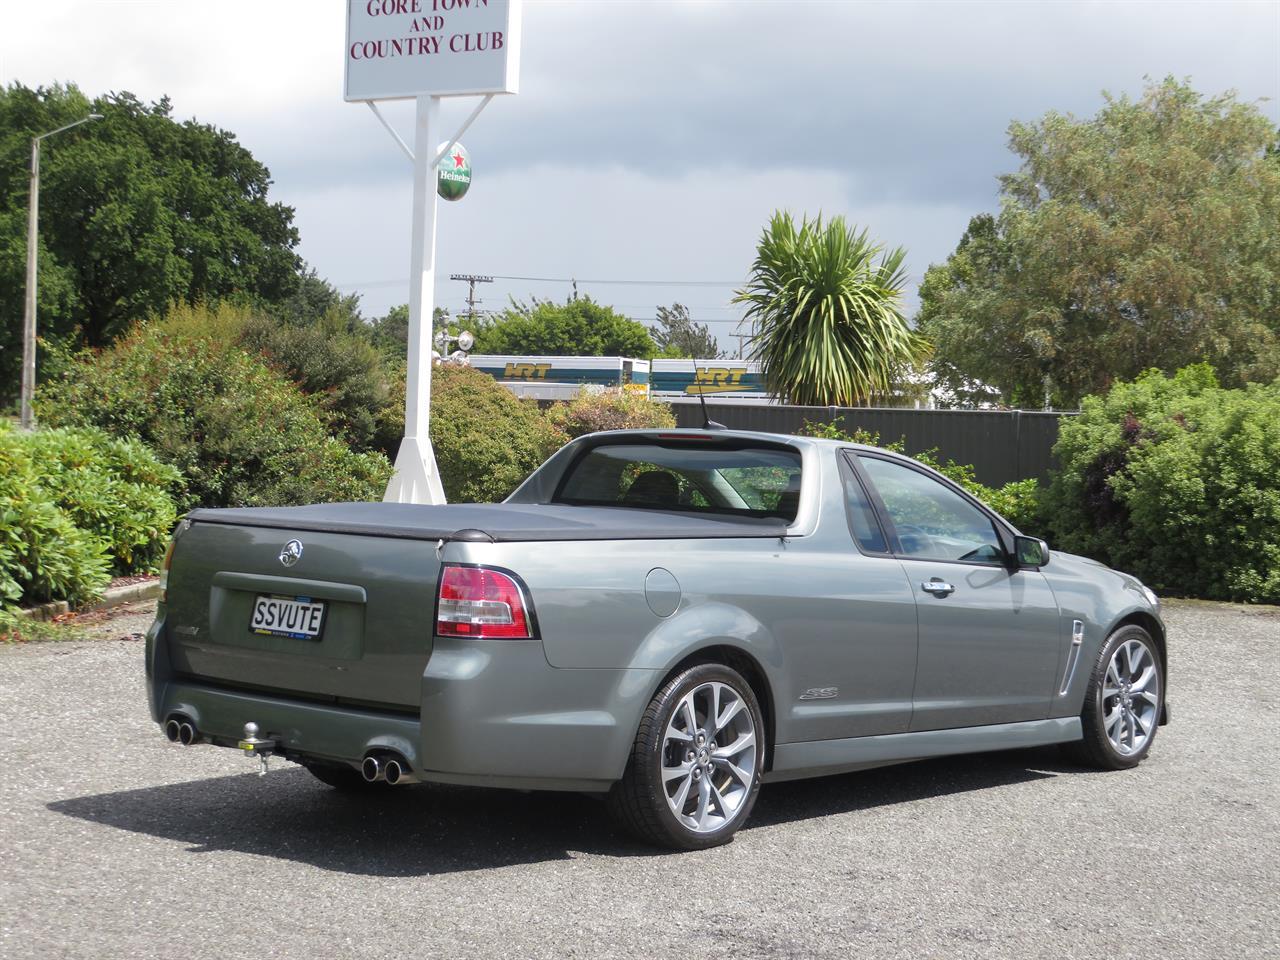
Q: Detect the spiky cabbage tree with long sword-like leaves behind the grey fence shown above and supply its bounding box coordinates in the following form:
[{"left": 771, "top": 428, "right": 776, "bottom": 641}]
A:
[{"left": 733, "top": 211, "right": 925, "bottom": 406}]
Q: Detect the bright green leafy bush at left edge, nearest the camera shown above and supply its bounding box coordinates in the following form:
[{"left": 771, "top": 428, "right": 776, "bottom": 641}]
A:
[{"left": 0, "top": 425, "right": 112, "bottom": 605}]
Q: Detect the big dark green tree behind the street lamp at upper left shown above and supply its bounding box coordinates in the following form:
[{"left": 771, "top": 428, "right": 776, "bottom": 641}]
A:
[{"left": 0, "top": 83, "right": 300, "bottom": 403}]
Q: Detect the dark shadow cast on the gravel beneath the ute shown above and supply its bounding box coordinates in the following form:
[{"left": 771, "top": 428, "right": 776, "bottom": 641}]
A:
[{"left": 47, "top": 750, "right": 1075, "bottom": 877}]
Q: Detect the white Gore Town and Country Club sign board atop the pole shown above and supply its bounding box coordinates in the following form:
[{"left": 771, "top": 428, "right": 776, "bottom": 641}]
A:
[{"left": 344, "top": 0, "right": 521, "bottom": 100}]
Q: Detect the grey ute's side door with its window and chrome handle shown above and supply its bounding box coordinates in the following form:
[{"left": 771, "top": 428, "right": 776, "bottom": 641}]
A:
[{"left": 856, "top": 453, "right": 1060, "bottom": 731}]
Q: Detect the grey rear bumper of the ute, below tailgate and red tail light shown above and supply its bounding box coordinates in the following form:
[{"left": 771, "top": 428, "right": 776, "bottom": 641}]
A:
[{"left": 148, "top": 637, "right": 658, "bottom": 791}]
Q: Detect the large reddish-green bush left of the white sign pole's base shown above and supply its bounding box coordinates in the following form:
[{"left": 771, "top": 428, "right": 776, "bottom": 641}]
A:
[{"left": 37, "top": 306, "right": 390, "bottom": 508}]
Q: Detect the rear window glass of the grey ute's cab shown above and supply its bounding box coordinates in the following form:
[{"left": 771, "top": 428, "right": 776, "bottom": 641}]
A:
[{"left": 553, "top": 443, "right": 800, "bottom": 522}]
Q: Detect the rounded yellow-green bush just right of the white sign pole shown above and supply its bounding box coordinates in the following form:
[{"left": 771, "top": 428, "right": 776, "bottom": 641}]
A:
[{"left": 431, "top": 365, "right": 567, "bottom": 503}]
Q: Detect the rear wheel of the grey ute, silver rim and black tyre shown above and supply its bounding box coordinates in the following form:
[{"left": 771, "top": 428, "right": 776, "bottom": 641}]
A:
[{"left": 608, "top": 663, "right": 765, "bottom": 850}]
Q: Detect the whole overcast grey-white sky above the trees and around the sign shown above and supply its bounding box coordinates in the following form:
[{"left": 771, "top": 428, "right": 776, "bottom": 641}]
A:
[{"left": 0, "top": 0, "right": 1280, "bottom": 349}]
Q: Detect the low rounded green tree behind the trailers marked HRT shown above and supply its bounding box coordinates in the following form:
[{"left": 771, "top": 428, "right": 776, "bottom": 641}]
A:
[{"left": 475, "top": 297, "right": 654, "bottom": 360}]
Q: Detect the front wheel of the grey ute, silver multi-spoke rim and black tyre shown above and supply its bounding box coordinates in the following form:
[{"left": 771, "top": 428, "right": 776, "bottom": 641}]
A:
[{"left": 1064, "top": 625, "right": 1165, "bottom": 771}]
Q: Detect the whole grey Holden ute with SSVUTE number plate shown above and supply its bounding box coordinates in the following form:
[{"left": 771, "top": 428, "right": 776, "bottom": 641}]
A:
[{"left": 146, "top": 430, "right": 1167, "bottom": 849}]
